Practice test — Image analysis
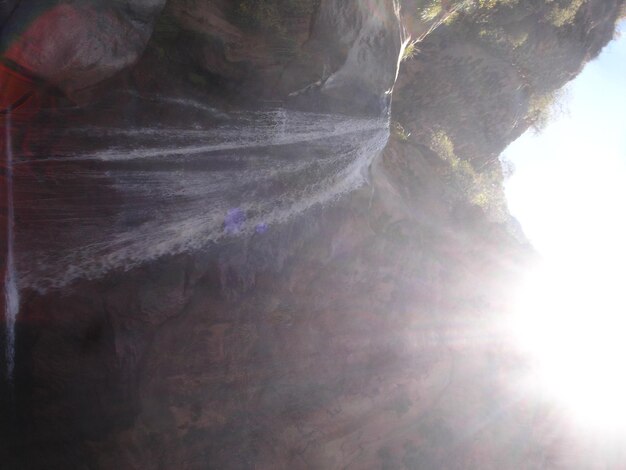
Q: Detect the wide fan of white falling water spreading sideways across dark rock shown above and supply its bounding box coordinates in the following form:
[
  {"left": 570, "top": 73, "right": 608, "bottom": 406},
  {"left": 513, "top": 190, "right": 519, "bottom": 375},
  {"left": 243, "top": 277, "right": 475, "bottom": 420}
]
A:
[{"left": 15, "top": 104, "right": 389, "bottom": 291}]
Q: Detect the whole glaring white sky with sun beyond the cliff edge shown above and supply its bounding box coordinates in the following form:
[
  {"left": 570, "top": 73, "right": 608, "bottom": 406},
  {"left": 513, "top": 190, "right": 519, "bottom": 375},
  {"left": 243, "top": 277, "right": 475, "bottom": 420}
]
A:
[{"left": 506, "top": 22, "right": 626, "bottom": 434}]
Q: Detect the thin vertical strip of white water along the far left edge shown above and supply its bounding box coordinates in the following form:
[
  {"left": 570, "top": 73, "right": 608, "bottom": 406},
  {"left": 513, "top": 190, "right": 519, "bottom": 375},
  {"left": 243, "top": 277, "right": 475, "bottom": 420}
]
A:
[{"left": 4, "top": 113, "right": 20, "bottom": 382}]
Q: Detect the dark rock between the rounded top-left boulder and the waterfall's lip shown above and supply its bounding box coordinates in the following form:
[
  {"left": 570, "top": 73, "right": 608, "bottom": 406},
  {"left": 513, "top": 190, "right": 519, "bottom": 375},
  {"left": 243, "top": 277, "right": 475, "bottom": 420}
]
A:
[{"left": 154, "top": 0, "right": 402, "bottom": 114}]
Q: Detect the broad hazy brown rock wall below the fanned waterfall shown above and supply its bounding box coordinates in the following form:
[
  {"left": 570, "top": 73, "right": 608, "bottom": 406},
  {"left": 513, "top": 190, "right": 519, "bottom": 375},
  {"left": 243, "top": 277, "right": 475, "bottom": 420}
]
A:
[{"left": 5, "top": 165, "right": 527, "bottom": 469}]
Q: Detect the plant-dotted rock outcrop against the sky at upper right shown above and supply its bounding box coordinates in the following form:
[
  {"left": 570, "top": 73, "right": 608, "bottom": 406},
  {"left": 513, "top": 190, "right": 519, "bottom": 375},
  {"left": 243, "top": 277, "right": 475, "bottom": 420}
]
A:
[{"left": 394, "top": 2, "right": 620, "bottom": 166}]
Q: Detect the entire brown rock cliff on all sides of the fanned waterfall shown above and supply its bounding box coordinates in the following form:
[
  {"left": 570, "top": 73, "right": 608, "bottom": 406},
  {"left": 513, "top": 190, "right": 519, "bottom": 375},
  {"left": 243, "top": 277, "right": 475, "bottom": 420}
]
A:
[{"left": 0, "top": 0, "right": 622, "bottom": 470}]
